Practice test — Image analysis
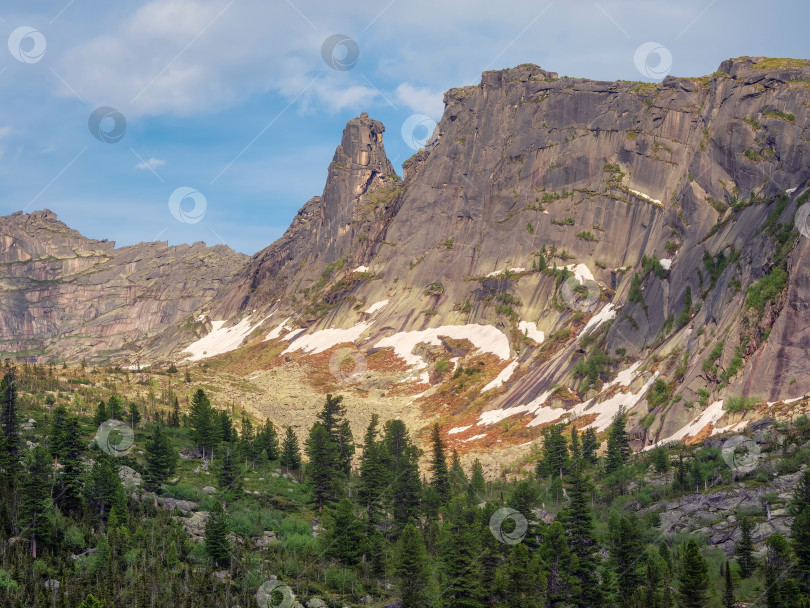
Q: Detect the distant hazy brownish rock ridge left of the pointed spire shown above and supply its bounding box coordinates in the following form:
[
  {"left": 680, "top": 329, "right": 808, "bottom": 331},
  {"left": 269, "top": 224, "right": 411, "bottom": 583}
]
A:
[{"left": 0, "top": 210, "right": 247, "bottom": 361}]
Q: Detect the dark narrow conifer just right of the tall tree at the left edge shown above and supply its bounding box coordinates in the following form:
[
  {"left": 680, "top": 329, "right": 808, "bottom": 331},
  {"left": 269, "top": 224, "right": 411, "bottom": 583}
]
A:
[{"left": 21, "top": 445, "right": 53, "bottom": 559}]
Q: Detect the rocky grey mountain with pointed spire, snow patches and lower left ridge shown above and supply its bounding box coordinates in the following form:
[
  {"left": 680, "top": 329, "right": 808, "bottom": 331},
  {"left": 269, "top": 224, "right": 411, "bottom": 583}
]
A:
[{"left": 0, "top": 57, "right": 810, "bottom": 458}]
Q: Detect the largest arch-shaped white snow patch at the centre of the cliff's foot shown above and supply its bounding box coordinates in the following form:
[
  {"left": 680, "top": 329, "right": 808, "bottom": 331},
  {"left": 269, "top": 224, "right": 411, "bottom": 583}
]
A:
[{"left": 374, "top": 323, "right": 509, "bottom": 369}]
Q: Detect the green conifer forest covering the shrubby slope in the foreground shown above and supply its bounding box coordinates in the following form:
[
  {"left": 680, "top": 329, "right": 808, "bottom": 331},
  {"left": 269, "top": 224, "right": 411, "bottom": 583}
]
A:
[{"left": 0, "top": 365, "right": 810, "bottom": 608}]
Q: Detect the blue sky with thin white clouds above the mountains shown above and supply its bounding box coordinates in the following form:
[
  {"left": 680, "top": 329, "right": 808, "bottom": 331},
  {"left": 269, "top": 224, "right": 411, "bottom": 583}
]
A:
[{"left": 0, "top": 0, "right": 810, "bottom": 254}]
